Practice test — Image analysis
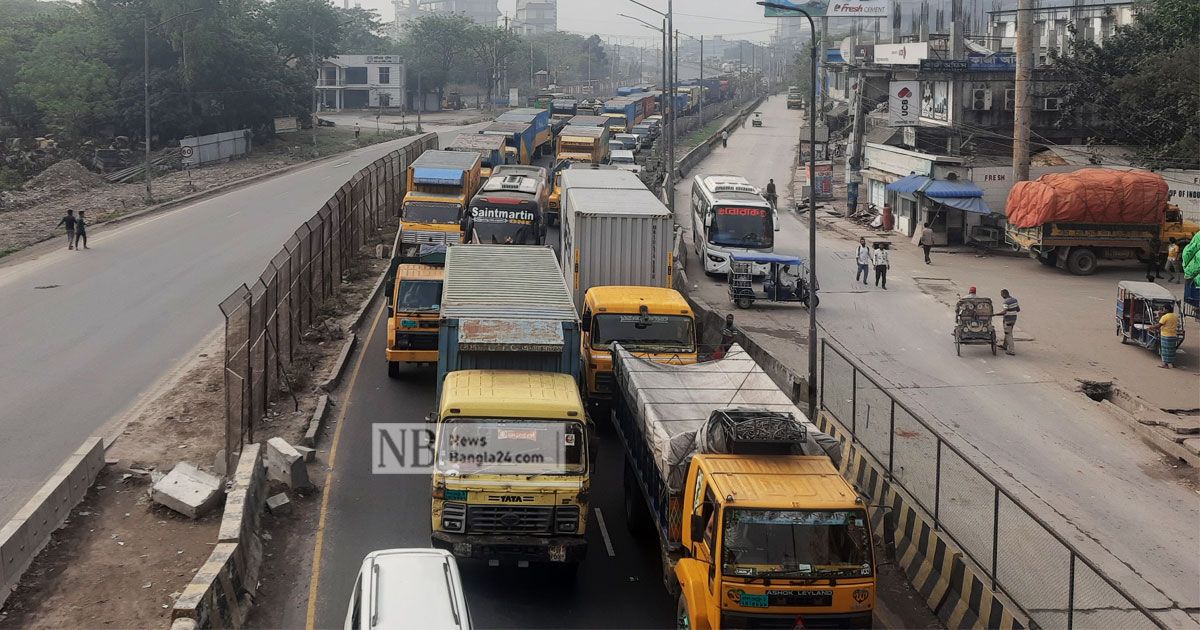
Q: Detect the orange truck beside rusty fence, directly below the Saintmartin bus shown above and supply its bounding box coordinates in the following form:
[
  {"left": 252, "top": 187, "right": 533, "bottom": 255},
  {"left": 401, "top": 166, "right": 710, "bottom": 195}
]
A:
[{"left": 384, "top": 238, "right": 445, "bottom": 378}]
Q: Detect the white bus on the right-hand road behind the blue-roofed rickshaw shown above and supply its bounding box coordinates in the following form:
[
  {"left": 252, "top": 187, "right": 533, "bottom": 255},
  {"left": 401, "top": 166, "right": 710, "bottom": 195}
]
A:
[{"left": 691, "top": 175, "right": 779, "bottom": 275}]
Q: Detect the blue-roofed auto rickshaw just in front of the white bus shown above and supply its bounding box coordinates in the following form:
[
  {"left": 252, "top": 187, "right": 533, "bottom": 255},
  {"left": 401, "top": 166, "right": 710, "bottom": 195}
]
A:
[{"left": 728, "top": 253, "right": 821, "bottom": 308}]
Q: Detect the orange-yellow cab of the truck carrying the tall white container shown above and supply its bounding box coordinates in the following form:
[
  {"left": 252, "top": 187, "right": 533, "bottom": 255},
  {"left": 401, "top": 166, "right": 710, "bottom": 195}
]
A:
[{"left": 580, "top": 287, "right": 697, "bottom": 403}]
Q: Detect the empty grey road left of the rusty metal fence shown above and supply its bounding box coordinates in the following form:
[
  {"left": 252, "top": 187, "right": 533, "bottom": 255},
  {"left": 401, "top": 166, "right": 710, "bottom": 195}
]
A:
[{"left": 0, "top": 123, "right": 477, "bottom": 522}]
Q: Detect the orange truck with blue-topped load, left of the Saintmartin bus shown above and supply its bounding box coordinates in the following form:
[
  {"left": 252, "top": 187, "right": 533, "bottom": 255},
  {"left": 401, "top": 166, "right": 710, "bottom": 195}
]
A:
[{"left": 400, "top": 150, "right": 480, "bottom": 244}]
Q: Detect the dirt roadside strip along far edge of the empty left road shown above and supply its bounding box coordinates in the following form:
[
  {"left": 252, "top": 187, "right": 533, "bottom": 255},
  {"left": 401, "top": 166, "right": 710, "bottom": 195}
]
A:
[{"left": 0, "top": 127, "right": 408, "bottom": 257}]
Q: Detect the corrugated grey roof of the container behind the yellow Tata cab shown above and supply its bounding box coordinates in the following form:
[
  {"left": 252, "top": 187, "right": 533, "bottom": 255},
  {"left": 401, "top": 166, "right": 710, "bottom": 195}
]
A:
[{"left": 442, "top": 245, "right": 578, "bottom": 322}]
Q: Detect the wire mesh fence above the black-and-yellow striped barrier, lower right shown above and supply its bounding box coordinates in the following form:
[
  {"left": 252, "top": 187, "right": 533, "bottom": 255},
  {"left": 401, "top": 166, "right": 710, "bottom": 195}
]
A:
[{"left": 820, "top": 338, "right": 1166, "bottom": 629}]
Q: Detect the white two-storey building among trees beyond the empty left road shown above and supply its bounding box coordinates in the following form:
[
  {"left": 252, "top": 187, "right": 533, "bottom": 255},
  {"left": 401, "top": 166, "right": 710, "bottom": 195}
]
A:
[{"left": 317, "top": 55, "right": 406, "bottom": 109}]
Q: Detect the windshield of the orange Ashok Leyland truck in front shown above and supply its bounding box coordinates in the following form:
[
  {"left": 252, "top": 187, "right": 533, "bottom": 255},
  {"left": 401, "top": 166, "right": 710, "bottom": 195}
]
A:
[{"left": 721, "top": 508, "right": 872, "bottom": 578}]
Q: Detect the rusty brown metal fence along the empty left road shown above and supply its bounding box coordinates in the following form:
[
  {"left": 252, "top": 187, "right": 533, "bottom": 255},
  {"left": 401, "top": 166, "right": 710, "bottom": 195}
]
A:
[{"left": 221, "top": 133, "right": 438, "bottom": 470}]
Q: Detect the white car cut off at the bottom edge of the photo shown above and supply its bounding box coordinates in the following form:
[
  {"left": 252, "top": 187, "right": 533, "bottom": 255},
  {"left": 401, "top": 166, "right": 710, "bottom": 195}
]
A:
[{"left": 344, "top": 548, "right": 472, "bottom": 630}]
